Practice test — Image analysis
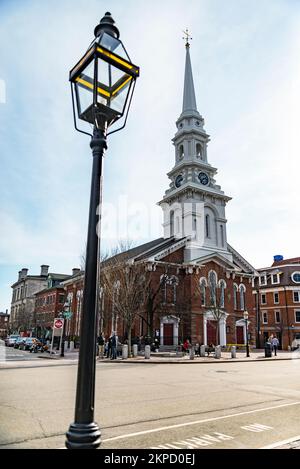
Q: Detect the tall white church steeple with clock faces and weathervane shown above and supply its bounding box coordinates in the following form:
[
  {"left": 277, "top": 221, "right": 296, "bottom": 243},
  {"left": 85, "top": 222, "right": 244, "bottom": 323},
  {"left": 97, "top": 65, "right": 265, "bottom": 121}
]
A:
[{"left": 159, "top": 31, "right": 232, "bottom": 261}]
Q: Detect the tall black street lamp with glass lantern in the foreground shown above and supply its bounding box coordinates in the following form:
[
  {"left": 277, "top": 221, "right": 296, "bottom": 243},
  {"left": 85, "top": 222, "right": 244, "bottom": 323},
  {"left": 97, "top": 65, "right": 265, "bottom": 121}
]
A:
[{"left": 66, "top": 13, "right": 139, "bottom": 449}]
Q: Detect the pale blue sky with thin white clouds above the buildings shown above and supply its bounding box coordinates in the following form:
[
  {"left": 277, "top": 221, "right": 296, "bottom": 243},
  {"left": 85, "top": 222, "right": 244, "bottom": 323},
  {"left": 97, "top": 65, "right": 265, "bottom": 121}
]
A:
[{"left": 0, "top": 0, "right": 300, "bottom": 310}]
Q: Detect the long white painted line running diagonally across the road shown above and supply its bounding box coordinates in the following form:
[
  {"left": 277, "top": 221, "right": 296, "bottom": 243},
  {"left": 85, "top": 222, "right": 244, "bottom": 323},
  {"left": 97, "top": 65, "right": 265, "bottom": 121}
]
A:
[{"left": 102, "top": 401, "right": 300, "bottom": 443}]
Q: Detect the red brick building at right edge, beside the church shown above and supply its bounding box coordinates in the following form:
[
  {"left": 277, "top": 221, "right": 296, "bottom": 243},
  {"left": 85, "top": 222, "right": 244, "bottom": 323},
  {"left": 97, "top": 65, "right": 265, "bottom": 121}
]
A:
[{"left": 253, "top": 256, "right": 300, "bottom": 350}]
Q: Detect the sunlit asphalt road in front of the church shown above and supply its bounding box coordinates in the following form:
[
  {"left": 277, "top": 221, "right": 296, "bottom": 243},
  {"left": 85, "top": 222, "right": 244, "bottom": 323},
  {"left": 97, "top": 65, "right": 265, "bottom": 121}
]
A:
[{"left": 0, "top": 360, "right": 300, "bottom": 449}]
